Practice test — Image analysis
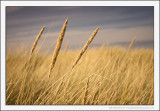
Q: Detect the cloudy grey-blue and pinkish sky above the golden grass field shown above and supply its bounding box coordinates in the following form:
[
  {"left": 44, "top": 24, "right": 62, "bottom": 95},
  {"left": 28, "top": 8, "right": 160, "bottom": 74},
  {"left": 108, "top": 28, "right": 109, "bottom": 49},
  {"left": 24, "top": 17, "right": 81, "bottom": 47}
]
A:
[{"left": 6, "top": 6, "right": 154, "bottom": 49}]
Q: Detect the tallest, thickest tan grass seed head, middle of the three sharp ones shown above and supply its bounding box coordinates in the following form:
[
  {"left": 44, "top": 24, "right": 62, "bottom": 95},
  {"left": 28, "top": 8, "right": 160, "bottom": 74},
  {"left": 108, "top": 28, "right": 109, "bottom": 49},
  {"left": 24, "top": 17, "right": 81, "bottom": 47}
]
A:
[{"left": 49, "top": 18, "right": 68, "bottom": 77}]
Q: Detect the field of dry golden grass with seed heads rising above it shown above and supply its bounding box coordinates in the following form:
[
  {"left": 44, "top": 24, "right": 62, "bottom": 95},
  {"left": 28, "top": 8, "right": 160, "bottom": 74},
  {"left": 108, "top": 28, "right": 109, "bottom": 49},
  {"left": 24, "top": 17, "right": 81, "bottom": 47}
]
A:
[{"left": 6, "top": 18, "right": 154, "bottom": 105}]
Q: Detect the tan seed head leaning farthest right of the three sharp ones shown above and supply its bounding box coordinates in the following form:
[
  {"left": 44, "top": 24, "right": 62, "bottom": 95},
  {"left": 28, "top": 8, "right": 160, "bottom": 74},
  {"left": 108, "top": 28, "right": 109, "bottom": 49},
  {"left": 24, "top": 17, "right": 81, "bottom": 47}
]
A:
[{"left": 72, "top": 27, "right": 99, "bottom": 69}]
